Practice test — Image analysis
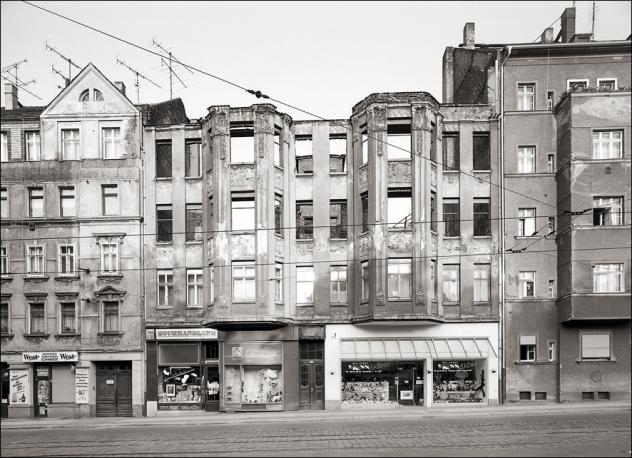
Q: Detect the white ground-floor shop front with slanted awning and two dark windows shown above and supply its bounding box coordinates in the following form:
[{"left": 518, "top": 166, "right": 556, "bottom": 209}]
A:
[{"left": 325, "top": 323, "right": 499, "bottom": 409}]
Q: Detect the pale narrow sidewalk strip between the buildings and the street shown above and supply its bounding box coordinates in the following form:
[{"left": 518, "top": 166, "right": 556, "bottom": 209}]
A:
[{"left": 0, "top": 401, "right": 632, "bottom": 429}]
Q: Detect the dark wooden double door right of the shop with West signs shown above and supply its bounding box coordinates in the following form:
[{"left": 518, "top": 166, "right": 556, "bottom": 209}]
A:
[{"left": 96, "top": 362, "right": 132, "bottom": 417}]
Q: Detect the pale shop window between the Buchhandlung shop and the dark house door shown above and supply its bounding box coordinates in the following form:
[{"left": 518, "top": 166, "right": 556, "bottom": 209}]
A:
[{"left": 221, "top": 342, "right": 284, "bottom": 411}]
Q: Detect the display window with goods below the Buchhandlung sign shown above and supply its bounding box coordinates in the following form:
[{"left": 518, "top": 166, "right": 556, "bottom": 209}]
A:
[{"left": 158, "top": 366, "right": 204, "bottom": 404}]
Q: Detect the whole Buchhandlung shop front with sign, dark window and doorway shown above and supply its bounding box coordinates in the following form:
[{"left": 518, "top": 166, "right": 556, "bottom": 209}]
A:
[{"left": 146, "top": 328, "right": 220, "bottom": 416}]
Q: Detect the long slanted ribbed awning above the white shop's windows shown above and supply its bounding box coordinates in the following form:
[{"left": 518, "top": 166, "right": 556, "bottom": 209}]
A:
[{"left": 340, "top": 337, "right": 498, "bottom": 361}]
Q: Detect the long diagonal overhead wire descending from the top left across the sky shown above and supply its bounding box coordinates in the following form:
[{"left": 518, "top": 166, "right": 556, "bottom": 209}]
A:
[{"left": 22, "top": 0, "right": 576, "bottom": 216}]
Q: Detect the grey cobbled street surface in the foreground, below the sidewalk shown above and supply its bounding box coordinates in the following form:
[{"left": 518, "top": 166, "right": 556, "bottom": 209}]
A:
[{"left": 2, "top": 409, "right": 631, "bottom": 457}]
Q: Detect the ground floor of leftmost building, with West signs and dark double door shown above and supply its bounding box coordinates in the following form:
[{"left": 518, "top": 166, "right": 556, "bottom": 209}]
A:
[{"left": 0, "top": 351, "right": 143, "bottom": 418}]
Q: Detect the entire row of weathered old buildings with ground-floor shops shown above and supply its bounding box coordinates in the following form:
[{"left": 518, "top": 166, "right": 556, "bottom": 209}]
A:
[{"left": 0, "top": 8, "right": 631, "bottom": 417}]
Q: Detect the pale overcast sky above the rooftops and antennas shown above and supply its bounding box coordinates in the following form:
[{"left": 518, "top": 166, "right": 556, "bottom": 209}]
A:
[{"left": 1, "top": 1, "right": 631, "bottom": 119}]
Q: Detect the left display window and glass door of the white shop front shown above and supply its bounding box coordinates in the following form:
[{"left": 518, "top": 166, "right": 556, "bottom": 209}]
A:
[{"left": 342, "top": 361, "right": 424, "bottom": 407}]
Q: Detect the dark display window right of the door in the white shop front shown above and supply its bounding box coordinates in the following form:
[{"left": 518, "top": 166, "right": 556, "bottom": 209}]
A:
[{"left": 433, "top": 361, "right": 486, "bottom": 403}]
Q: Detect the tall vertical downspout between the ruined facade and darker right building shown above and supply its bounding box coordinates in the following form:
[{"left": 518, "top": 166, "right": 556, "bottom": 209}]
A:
[{"left": 496, "top": 46, "right": 511, "bottom": 404}]
